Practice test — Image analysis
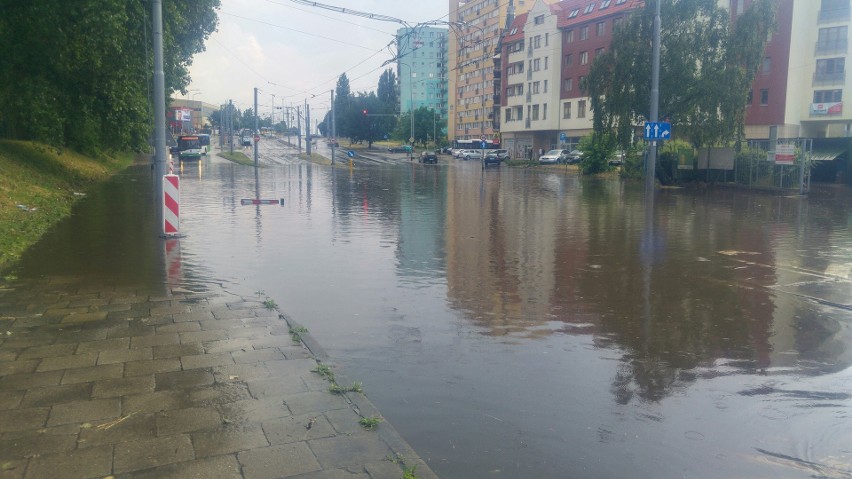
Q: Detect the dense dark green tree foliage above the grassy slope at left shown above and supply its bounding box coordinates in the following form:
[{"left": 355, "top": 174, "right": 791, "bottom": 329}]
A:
[{"left": 0, "top": 0, "right": 219, "bottom": 154}]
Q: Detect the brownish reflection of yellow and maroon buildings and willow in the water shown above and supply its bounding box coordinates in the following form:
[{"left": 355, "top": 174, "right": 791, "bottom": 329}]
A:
[{"left": 446, "top": 169, "right": 850, "bottom": 402}]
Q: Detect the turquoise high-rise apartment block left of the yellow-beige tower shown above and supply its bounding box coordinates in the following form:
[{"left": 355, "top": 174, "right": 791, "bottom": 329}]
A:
[{"left": 396, "top": 26, "right": 448, "bottom": 124}]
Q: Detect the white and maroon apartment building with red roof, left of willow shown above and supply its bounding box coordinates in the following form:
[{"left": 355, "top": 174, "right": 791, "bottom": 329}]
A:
[{"left": 501, "top": 0, "right": 641, "bottom": 156}]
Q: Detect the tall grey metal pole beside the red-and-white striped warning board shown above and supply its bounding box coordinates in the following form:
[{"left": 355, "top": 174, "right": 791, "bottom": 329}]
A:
[{"left": 151, "top": 0, "right": 169, "bottom": 232}]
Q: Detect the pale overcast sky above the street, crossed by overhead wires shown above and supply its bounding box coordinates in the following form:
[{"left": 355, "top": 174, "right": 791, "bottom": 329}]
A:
[{"left": 175, "top": 0, "right": 448, "bottom": 119}]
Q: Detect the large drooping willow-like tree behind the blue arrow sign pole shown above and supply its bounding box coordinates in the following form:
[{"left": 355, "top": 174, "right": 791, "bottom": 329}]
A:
[{"left": 581, "top": 0, "right": 775, "bottom": 154}]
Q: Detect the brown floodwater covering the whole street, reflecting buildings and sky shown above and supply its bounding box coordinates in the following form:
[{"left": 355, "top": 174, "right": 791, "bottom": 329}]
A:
[{"left": 13, "top": 147, "right": 852, "bottom": 479}]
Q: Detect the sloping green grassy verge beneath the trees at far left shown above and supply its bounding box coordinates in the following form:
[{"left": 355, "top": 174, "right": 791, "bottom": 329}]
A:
[{"left": 0, "top": 140, "right": 133, "bottom": 271}]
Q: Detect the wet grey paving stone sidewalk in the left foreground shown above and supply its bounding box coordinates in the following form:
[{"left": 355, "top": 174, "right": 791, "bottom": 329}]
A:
[{"left": 0, "top": 279, "right": 437, "bottom": 479}]
